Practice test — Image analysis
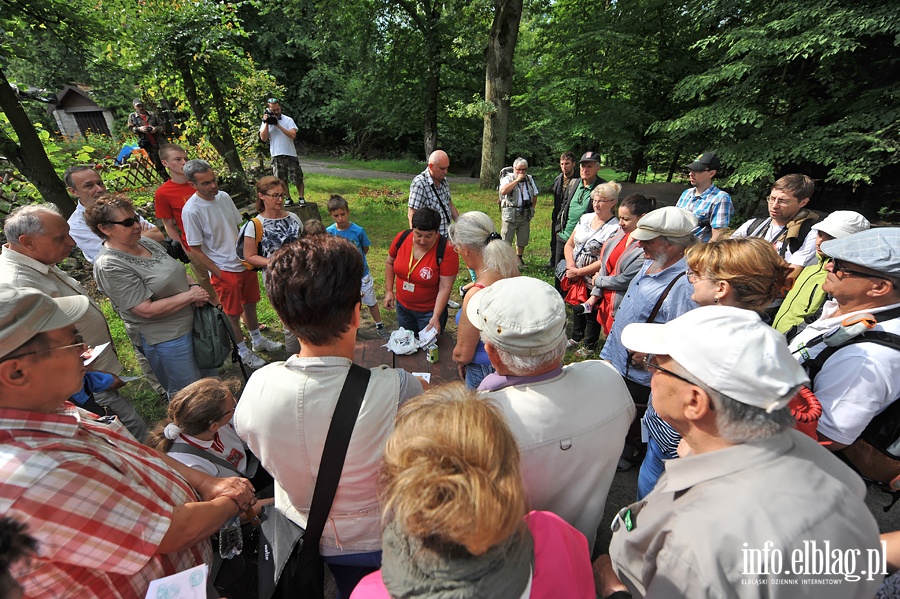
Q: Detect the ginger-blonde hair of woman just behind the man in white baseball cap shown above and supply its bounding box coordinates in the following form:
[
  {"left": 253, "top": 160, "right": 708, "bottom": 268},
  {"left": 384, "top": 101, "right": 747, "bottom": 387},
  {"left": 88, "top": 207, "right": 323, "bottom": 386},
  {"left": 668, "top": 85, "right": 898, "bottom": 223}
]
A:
[{"left": 684, "top": 237, "right": 792, "bottom": 312}]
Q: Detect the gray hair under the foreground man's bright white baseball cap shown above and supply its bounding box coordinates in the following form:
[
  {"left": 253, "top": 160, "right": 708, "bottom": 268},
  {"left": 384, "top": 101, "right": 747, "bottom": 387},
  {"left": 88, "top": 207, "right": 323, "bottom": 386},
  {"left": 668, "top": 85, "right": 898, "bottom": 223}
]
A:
[{"left": 670, "top": 362, "right": 800, "bottom": 443}]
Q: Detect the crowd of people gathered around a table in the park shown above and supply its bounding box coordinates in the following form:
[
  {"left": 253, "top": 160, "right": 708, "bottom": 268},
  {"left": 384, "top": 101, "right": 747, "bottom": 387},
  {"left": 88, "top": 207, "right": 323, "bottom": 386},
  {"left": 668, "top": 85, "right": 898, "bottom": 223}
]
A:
[{"left": 0, "top": 145, "right": 900, "bottom": 599}]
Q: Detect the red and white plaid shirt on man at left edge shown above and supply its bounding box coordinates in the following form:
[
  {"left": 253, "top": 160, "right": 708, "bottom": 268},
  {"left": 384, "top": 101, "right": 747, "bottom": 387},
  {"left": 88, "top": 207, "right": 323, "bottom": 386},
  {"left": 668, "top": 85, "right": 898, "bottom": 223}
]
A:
[{"left": 0, "top": 402, "right": 212, "bottom": 599}]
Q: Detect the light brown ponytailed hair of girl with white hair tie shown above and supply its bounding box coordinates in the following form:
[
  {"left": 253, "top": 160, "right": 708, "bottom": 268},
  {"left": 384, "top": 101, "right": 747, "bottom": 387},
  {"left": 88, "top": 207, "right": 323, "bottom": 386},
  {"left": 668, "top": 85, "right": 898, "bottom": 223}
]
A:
[{"left": 147, "top": 378, "right": 241, "bottom": 452}]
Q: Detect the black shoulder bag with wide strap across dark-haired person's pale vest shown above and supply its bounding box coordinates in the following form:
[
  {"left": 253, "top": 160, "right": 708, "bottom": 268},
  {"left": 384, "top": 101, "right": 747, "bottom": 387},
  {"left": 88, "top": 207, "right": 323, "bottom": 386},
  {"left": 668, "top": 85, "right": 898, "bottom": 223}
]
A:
[{"left": 258, "top": 364, "right": 372, "bottom": 599}]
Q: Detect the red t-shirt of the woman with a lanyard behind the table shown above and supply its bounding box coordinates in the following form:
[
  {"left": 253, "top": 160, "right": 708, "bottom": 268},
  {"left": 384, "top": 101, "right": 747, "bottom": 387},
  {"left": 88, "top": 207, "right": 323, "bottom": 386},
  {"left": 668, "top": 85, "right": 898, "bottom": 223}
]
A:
[{"left": 388, "top": 231, "right": 459, "bottom": 312}]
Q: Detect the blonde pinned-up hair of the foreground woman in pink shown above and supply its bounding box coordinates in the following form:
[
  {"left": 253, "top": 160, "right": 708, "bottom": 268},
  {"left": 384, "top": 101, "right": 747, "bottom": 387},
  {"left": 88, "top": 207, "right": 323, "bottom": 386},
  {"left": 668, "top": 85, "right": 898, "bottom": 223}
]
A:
[{"left": 381, "top": 383, "right": 526, "bottom": 556}]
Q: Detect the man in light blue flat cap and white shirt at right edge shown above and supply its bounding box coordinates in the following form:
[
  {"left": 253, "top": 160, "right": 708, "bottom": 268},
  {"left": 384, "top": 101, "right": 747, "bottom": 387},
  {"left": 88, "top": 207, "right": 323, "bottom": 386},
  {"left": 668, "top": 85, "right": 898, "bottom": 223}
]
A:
[{"left": 789, "top": 227, "right": 900, "bottom": 458}]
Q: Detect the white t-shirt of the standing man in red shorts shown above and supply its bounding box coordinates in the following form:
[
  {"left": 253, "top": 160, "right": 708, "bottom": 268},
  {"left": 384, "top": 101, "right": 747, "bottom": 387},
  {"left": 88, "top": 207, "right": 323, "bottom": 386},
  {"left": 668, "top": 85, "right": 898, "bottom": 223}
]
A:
[{"left": 181, "top": 191, "right": 247, "bottom": 272}]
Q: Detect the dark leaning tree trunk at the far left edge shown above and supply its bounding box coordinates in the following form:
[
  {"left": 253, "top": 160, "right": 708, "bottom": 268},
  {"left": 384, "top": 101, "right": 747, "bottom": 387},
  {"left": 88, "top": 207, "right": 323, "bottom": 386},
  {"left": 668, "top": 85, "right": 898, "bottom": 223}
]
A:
[{"left": 0, "top": 69, "right": 75, "bottom": 218}]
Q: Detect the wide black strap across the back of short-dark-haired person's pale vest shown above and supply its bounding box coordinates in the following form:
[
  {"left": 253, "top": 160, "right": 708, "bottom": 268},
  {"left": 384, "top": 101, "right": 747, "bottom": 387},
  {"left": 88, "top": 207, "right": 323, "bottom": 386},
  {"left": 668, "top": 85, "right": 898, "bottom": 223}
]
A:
[{"left": 300, "top": 364, "right": 372, "bottom": 572}]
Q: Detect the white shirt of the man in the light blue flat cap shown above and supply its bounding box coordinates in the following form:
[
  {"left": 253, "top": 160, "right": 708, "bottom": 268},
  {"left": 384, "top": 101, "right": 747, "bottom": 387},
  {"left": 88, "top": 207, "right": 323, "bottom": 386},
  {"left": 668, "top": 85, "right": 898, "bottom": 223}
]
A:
[{"left": 789, "top": 300, "right": 900, "bottom": 445}]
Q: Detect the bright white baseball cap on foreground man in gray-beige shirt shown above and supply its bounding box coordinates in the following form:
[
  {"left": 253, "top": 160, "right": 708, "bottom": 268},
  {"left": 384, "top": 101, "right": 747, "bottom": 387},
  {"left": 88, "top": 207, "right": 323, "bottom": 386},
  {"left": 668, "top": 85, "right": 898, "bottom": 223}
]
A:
[{"left": 622, "top": 306, "right": 809, "bottom": 412}]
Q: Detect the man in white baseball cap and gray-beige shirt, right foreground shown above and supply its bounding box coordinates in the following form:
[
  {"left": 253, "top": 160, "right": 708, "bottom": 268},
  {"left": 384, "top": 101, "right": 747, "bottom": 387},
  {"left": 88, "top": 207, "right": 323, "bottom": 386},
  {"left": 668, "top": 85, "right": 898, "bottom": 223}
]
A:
[{"left": 594, "top": 306, "right": 885, "bottom": 599}]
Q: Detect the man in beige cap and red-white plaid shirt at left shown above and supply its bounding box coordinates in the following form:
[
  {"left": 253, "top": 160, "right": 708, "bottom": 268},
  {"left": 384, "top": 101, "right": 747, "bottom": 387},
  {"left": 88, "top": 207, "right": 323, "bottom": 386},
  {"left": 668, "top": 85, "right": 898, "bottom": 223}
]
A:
[{"left": 0, "top": 287, "right": 255, "bottom": 598}]
